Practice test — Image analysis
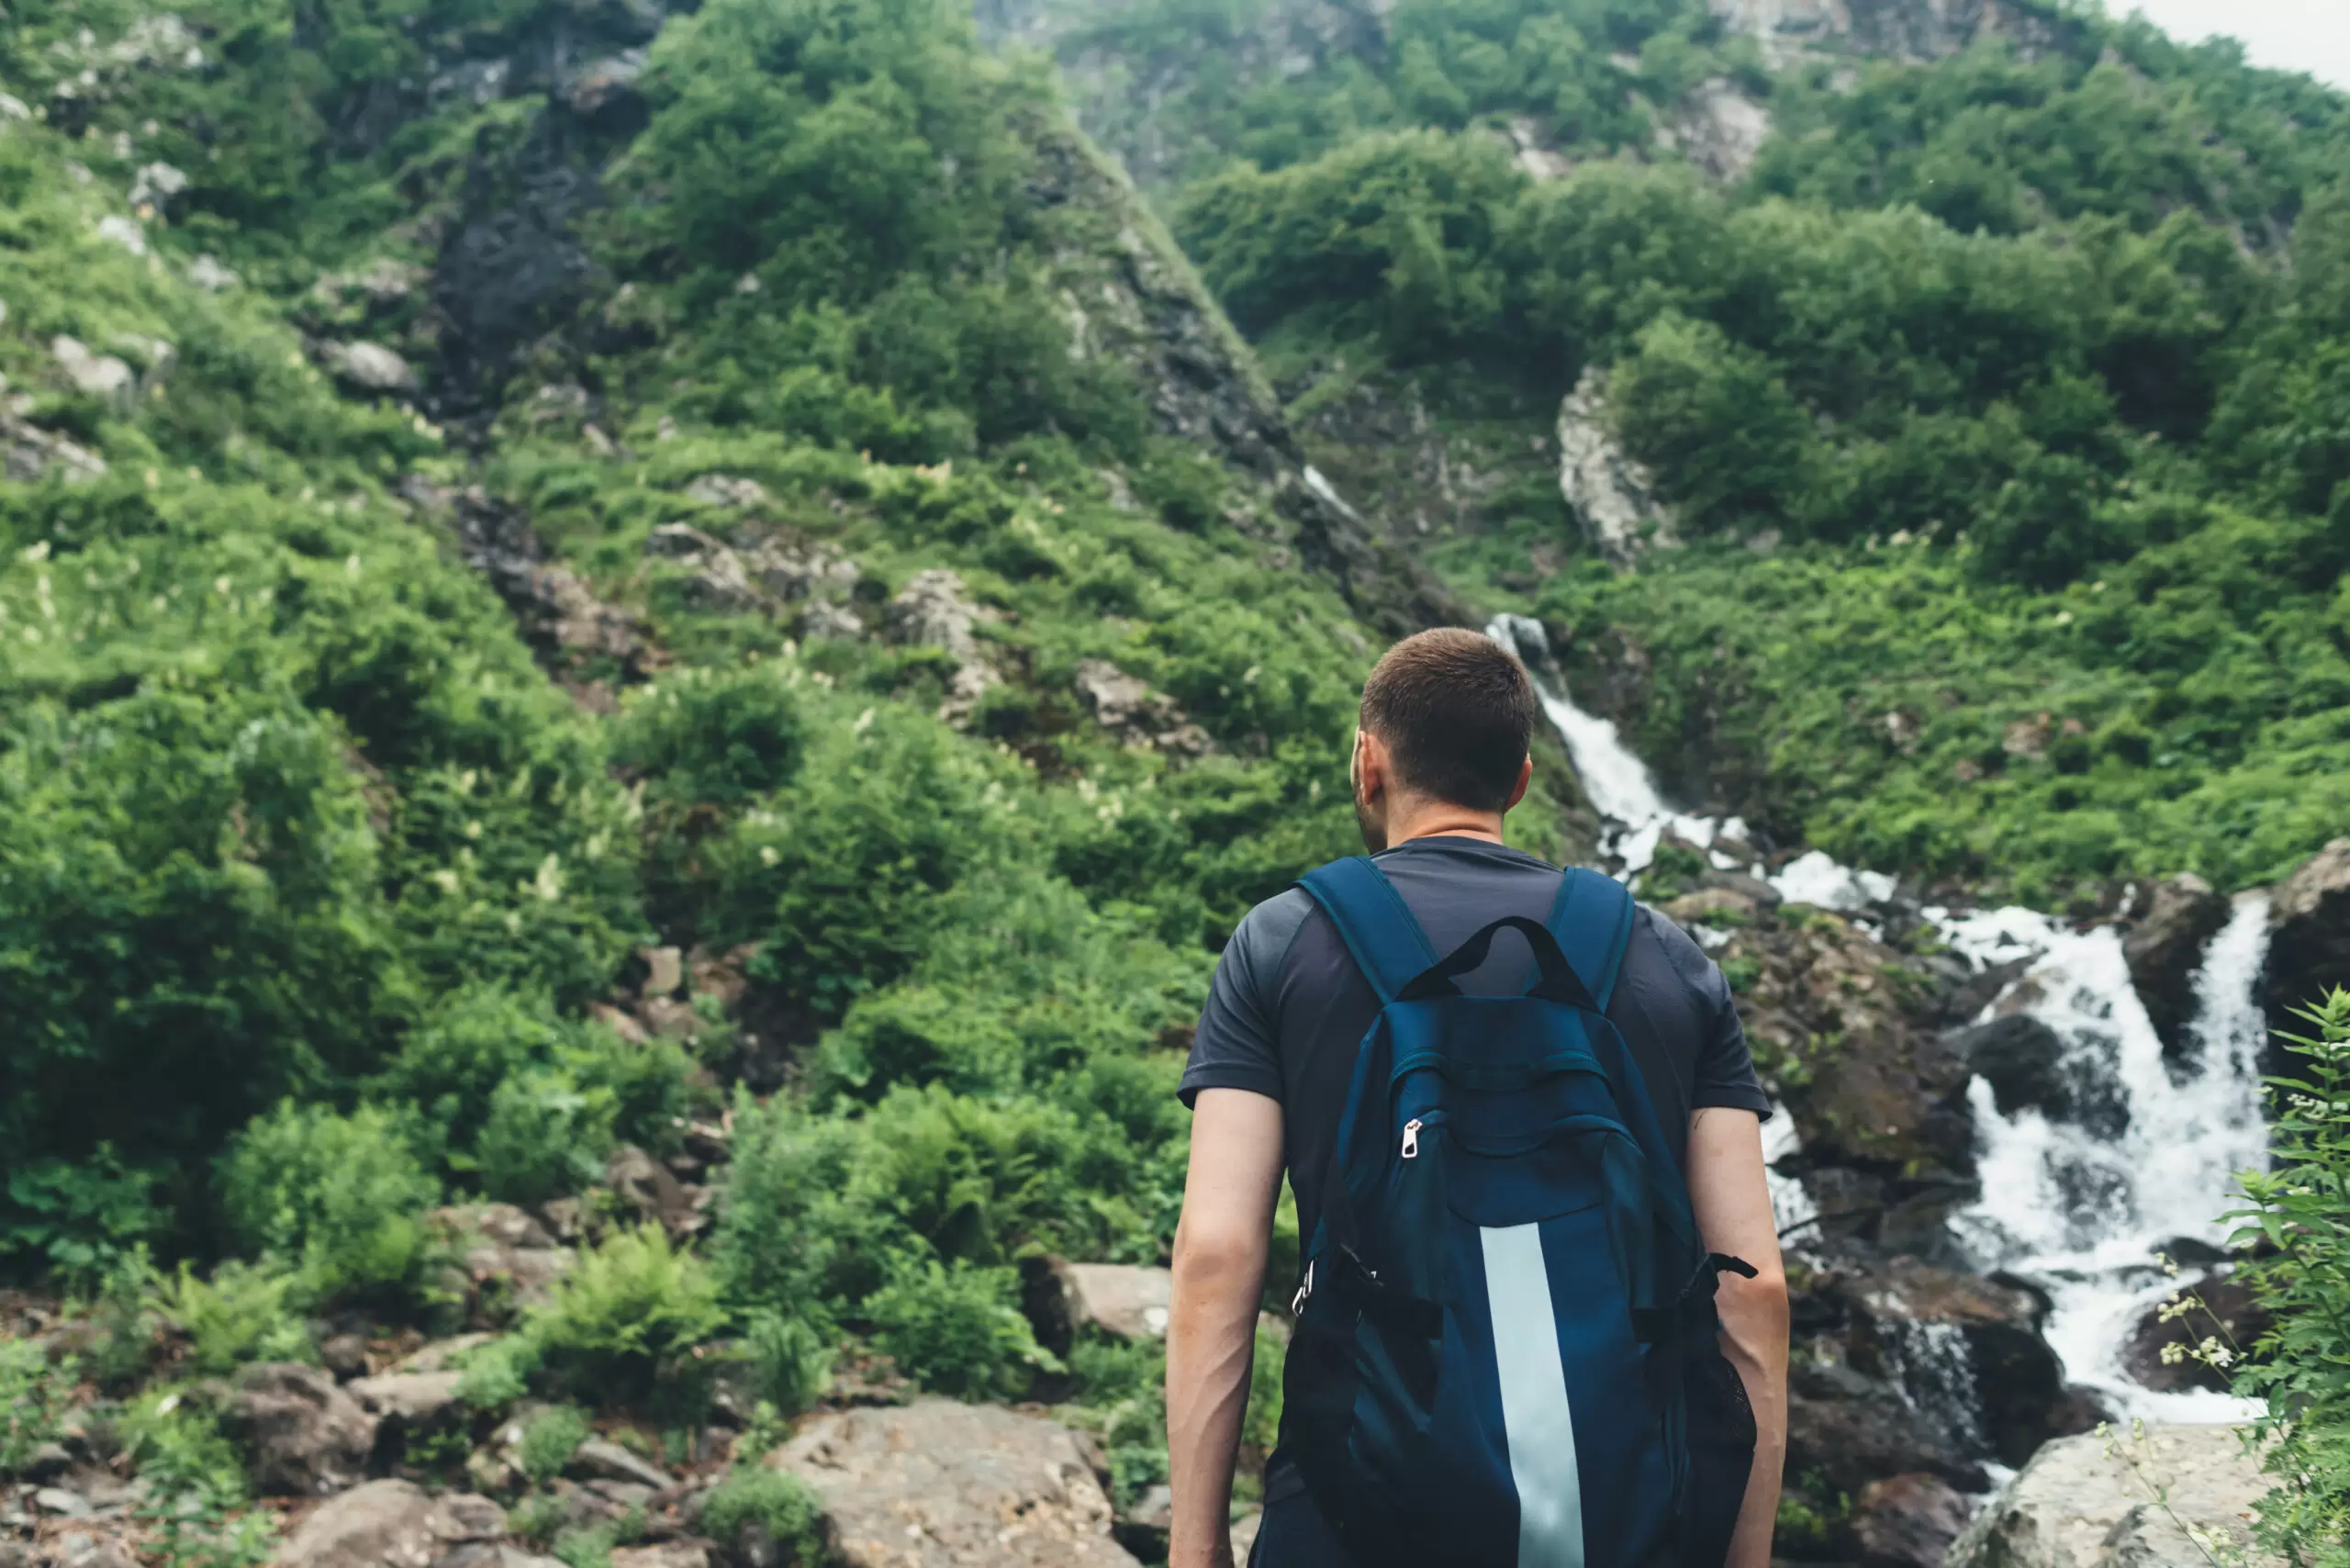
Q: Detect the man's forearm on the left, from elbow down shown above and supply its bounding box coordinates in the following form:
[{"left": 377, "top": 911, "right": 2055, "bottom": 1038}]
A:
[{"left": 1168, "top": 1232, "right": 1264, "bottom": 1568}]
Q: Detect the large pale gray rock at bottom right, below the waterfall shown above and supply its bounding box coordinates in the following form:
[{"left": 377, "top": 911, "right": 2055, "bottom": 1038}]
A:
[{"left": 1948, "top": 1427, "right": 2275, "bottom": 1568}]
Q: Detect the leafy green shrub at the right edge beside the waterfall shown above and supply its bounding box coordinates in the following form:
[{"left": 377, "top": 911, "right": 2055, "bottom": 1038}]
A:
[{"left": 2230, "top": 990, "right": 2350, "bottom": 1568}]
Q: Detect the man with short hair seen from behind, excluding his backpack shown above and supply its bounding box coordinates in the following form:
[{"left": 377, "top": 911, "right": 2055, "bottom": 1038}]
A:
[{"left": 1168, "top": 630, "right": 1788, "bottom": 1568}]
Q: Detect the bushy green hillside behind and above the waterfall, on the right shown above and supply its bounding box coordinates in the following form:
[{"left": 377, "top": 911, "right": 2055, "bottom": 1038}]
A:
[{"left": 1020, "top": 3, "right": 2350, "bottom": 901}]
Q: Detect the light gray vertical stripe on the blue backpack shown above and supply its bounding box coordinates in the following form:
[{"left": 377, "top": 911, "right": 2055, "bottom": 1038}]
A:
[{"left": 1478, "top": 1225, "right": 1583, "bottom": 1568}]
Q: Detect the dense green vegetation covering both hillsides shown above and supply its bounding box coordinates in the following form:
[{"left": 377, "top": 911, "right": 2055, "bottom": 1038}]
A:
[{"left": 0, "top": 0, "right": 2350, "bottom": 1568}]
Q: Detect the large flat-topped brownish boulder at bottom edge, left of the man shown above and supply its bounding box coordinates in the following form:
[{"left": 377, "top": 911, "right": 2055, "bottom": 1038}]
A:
[{"left": 768, "top": 1399, "right": 1135, "bottom": 1568}]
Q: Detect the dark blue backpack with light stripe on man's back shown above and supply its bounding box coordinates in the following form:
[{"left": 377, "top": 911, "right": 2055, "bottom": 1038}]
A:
[{"left": 1281, "top": 858, "right": 1753, "bottom": 1568}]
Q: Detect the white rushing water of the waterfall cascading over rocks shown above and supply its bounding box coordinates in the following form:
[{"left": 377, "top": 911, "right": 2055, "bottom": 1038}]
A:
[{"left": 1487, "top": 616, "right": 2267, "bottom": 1422}]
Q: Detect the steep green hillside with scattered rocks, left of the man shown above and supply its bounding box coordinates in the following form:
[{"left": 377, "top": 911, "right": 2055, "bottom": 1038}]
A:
[{"left": 0, "top": 0, "right": 1589, "bottom": 1563}]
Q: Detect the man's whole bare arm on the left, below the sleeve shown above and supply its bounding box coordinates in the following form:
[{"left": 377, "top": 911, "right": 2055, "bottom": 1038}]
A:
[{"left": 1168, "top": 1089, "right": 1281, "bottom": 1568}]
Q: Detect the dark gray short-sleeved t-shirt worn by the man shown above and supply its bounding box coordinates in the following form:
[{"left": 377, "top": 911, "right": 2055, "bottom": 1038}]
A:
[{"left": 1180, "top": 837, "right": 1770, "bottom": 1238}]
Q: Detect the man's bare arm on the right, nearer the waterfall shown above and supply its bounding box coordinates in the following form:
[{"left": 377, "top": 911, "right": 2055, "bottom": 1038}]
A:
[{"left": 1690, "top": 1107, "right": 1788, "bottom": 1568}]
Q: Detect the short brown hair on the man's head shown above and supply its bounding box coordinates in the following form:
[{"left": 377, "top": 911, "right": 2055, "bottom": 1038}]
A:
[{"left": 1363, "top": 625, "right": 1537, "bottom": 811}]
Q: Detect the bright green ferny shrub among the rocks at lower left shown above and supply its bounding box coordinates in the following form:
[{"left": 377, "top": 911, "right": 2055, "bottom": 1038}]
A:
[{"left": 521, "top": 1225, "right": 726, "bottom": 1406}]
